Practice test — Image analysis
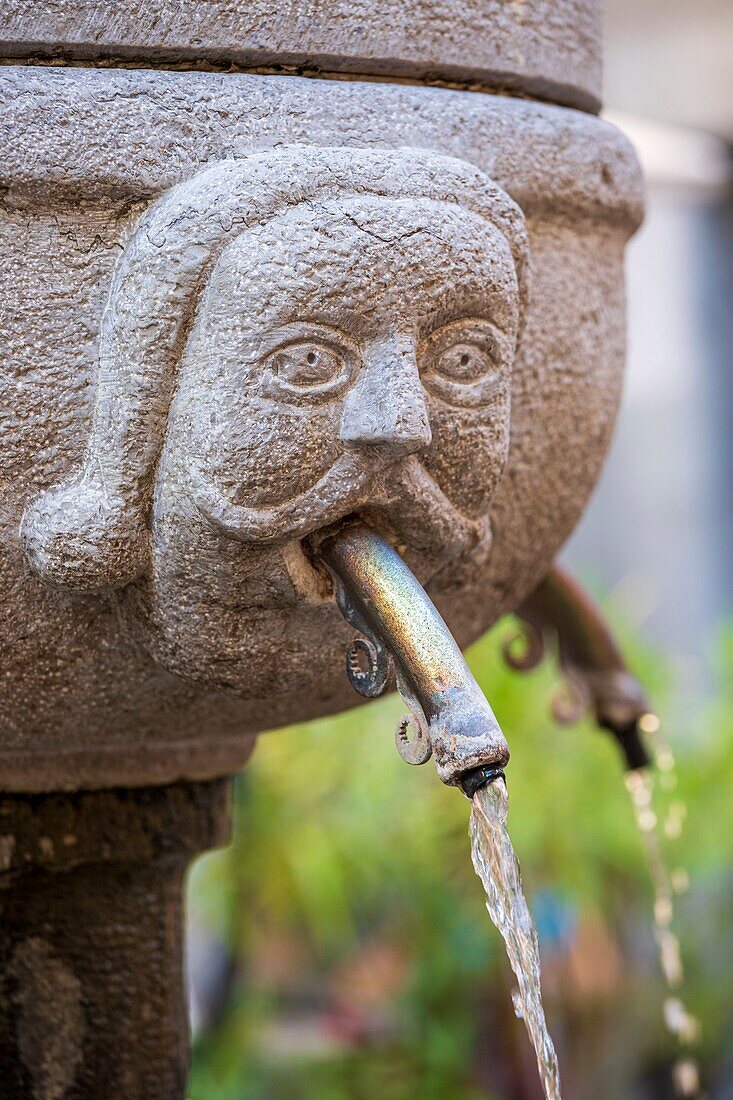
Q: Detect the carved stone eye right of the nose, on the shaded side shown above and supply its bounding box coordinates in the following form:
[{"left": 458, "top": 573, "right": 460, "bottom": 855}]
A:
[{"left": 419, "top": 318, "right": 507, "bottom": 407}]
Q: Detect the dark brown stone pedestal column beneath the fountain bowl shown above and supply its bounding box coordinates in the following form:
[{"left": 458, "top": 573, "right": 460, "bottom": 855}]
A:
[{"left": 0, "top": 781, "right": 229, "bottom": 1100}]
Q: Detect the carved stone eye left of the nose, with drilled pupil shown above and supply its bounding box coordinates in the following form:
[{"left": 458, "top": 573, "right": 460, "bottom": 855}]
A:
[{"left": 263, "top": 340, "right": 353, "bottom": 400}]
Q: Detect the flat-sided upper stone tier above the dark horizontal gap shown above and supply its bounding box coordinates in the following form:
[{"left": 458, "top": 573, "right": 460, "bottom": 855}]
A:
[{"left": 0, "top": 0, "right": 601, "bottom": 111}]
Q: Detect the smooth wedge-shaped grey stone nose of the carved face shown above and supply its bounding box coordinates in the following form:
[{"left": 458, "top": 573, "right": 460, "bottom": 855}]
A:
[{"left": 340, "top": 341, "right": 433, "bottom": 454}]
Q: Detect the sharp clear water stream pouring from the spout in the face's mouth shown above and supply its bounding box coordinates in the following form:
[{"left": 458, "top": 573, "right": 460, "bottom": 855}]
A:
[{"left": 470, "top": 780, "right": 561, "bottom": 1100}]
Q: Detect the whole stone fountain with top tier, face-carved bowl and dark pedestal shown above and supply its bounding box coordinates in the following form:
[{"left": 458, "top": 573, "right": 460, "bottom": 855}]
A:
[{"left": 0, "top": 0, "right": 642, "bottom": 1100}]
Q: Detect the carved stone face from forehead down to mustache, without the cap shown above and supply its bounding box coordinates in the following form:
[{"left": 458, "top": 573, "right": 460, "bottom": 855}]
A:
[{"left": 179, "top": 198, "right": 518, "bottom": 562}]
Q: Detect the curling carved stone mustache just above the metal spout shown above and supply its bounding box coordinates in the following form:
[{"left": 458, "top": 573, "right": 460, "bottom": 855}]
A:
[{"left": 189, "top": 451, "right": 482, "bottom": 557}]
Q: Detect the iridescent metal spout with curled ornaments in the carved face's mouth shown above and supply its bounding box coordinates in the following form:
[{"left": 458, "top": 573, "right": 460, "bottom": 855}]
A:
[{"left": 316, "top": 520, "right": 510, "bottom": 796}]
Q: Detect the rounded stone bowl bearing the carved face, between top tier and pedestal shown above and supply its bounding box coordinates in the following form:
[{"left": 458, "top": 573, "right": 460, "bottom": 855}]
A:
[{"left": 0, "top": 67, "right": 641, "bottom": 790}]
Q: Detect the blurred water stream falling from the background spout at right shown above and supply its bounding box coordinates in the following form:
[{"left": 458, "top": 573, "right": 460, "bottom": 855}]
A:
[{"left": 626, "top": 714, "right": 703, "bottom": 1100}]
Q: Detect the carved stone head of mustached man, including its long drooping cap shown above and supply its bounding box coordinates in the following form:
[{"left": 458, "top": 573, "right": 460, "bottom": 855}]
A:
[{"left": 21, "top": 146, "right": 527, "bottom": 704}]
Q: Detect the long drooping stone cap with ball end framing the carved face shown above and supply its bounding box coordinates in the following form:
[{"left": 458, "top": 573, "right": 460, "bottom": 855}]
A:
[{"left": 21, "top": 146, "right": 527, "bottom": 591}]
